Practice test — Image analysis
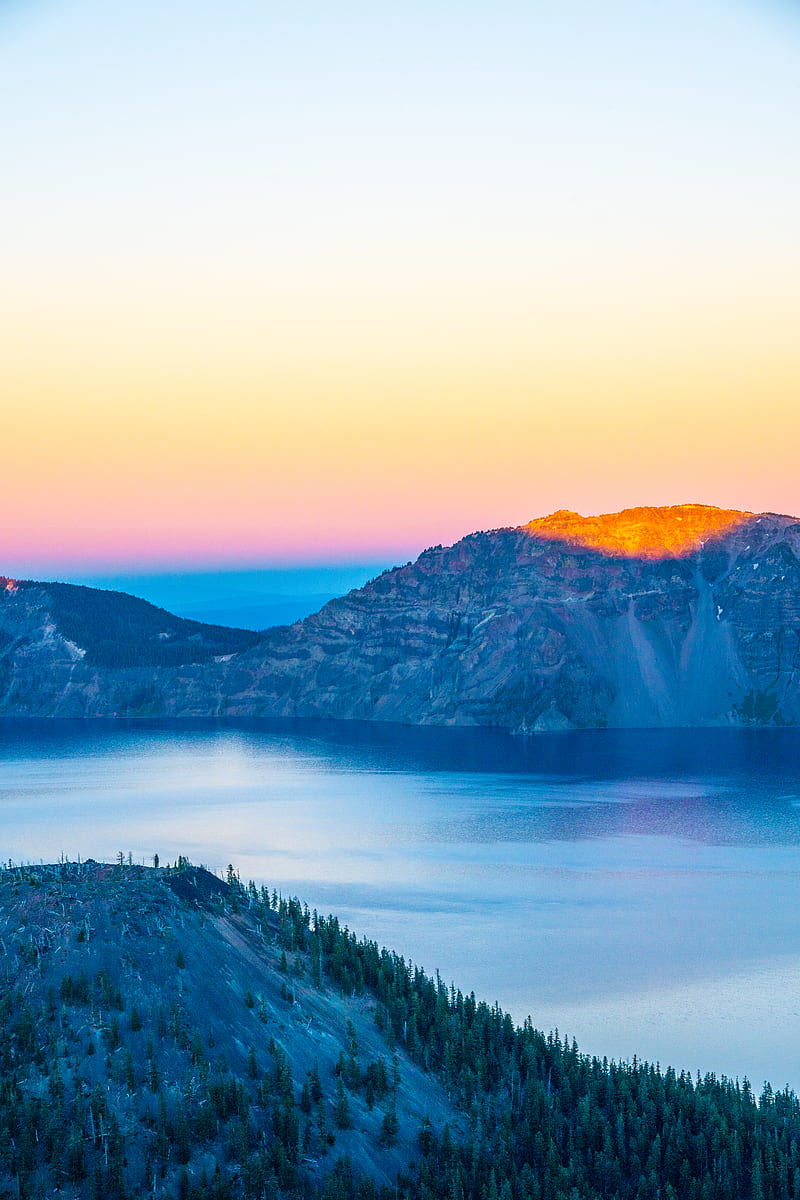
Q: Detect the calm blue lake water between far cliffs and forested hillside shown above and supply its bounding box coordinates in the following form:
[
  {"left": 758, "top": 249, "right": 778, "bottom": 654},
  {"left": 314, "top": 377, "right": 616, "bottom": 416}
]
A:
[{"left": 0, "top": 721, "right": 800, "bottom": 1088}]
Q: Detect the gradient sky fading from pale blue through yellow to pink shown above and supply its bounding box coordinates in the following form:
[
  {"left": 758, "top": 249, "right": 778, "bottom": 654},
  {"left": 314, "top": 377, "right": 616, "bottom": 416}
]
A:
[{"left": 0, "top": 0, "right": 800, "bottom": 576}]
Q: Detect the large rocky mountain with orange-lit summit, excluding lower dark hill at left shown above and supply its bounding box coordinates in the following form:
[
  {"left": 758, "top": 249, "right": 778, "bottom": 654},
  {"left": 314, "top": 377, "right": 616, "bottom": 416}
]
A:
[{"left": 201, "top": 505, "right": 800, "bottom": 730}]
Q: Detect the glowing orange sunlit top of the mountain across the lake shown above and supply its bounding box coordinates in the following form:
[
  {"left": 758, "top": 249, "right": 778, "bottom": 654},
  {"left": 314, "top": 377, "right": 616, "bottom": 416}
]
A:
[{"left": 522, "top": 504, "right": 753, "bottom": 558}]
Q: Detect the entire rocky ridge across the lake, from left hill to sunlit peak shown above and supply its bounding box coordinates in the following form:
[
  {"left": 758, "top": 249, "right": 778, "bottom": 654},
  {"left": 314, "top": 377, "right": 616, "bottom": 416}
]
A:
[{"left": 0, "top": 504, "right": 800, "bottom": 732}]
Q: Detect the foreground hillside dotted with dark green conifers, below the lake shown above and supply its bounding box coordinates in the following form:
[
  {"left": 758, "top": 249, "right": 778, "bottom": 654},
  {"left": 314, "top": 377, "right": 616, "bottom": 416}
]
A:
[{"left": 0, "top": 854, "right": 800, "bottom": 1200}]
